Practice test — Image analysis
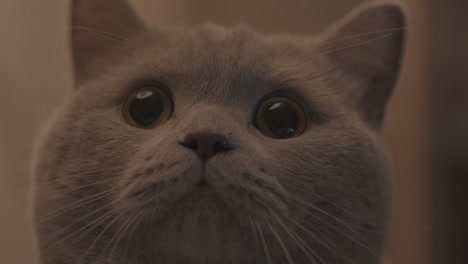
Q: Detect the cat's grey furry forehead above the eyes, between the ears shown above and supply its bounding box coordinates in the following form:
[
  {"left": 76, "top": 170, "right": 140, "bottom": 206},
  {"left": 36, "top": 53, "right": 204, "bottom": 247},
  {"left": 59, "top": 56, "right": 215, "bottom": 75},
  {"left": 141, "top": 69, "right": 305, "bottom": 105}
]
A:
[{"left": 119, "top": 26, "right": 330, "bottom": 104}]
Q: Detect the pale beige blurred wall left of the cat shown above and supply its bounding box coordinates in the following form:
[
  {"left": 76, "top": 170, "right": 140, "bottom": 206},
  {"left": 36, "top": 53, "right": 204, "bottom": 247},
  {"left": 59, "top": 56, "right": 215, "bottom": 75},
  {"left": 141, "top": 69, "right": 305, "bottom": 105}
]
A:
[{"left": 0, "top": 0, "right": 70, "bottom": 264}]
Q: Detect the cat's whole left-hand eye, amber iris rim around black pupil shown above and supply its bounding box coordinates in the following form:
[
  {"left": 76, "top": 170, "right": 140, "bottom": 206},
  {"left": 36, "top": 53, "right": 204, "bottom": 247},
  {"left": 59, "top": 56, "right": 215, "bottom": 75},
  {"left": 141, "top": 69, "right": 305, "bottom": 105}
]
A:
[{"left": 123, "top": 86, "right": 173, "bottom": 128}]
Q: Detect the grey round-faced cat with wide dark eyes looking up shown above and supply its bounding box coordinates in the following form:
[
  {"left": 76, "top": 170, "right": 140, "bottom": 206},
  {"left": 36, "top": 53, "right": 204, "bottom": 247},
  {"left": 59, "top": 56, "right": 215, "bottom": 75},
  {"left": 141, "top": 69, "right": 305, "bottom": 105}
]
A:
[{"left": 33, "top": 0, "right": 406, "bottom": 264}]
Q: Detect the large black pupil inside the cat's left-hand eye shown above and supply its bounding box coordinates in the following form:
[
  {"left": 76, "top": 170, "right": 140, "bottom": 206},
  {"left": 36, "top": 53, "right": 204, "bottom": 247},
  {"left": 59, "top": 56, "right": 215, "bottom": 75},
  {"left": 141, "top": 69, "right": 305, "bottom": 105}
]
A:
[{"left": 129, "top": 91, "right": 164, "bottom": 126}]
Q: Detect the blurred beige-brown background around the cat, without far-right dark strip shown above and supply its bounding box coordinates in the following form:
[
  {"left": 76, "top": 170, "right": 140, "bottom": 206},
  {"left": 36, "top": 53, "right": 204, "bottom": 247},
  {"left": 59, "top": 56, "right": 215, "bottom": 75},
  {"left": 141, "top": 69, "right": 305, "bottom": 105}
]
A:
[{"left": 0, "top": 0, "right": 432, "bottom": 264}]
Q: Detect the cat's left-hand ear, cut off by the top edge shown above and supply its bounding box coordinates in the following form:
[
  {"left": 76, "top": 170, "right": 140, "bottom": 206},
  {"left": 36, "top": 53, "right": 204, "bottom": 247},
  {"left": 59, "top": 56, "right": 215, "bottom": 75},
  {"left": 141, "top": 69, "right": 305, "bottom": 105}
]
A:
[{"left": 71, "top": 0, "right": 146, "bottom": 84}]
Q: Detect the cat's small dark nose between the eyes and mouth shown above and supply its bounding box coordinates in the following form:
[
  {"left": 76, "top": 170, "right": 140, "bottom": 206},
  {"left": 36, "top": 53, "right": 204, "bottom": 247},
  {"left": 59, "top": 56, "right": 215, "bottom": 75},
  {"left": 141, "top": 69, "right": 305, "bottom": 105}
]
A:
[{"left": 180, "top": 132, "right": 232, "bottom": 162}]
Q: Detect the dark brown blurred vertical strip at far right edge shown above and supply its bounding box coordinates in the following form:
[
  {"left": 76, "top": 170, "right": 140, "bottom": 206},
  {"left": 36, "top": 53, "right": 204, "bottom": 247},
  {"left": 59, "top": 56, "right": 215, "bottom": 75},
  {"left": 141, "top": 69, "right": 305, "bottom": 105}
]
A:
[{"left": 428, "top": 0, "right": 468, "bottom": 264}]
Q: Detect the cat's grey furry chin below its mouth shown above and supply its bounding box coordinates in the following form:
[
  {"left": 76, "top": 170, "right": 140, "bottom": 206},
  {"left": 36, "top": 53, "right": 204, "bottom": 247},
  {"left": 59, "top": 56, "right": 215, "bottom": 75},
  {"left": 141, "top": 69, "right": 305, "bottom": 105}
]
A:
[{"left": 130, "top": 186, "right": 253, "bottom": 263}]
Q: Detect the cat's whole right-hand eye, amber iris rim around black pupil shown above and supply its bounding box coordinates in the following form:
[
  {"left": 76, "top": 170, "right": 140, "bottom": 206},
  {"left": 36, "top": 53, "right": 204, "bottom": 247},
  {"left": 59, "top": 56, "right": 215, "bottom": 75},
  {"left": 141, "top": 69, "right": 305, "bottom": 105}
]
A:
[{"left": 255, "top": 96, "right": 307, "bottom": 139}]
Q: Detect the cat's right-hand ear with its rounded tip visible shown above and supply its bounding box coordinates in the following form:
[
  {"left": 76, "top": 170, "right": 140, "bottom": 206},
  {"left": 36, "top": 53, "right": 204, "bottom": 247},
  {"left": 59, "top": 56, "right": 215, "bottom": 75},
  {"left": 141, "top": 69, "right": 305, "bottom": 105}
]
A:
[{"left": 320, "top": 1, "right": 406, "bottom": 128}]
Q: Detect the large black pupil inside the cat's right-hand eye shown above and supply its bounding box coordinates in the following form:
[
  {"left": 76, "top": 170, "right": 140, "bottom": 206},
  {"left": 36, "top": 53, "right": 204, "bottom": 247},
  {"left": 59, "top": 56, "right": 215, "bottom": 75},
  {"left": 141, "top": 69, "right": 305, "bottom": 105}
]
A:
[{"left": 264, "top": 102, "right": 299, "bottom": 138}]
